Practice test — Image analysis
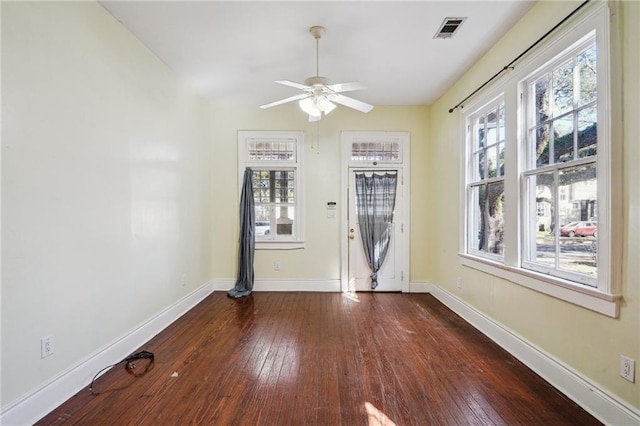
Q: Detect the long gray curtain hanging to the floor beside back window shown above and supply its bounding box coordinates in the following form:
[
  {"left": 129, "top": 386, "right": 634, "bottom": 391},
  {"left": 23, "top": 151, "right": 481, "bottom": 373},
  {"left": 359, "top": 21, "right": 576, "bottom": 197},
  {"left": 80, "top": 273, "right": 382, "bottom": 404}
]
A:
[{"left": 227, "top": 167, "right": 256, "bottom": 299}]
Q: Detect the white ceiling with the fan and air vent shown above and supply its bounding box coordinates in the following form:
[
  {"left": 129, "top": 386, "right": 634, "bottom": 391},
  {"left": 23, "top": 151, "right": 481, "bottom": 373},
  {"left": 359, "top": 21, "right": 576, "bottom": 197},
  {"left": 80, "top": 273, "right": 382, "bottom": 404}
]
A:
[{"left": 101, "top": 0, "right": 534, "bottom": 105}]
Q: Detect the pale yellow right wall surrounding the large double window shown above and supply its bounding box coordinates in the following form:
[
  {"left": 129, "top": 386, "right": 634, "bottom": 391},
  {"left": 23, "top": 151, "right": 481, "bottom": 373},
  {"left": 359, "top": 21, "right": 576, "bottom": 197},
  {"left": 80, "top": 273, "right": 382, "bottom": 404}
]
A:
[{"left": 422, "top": 2, "right": 640, "bottom": 408}]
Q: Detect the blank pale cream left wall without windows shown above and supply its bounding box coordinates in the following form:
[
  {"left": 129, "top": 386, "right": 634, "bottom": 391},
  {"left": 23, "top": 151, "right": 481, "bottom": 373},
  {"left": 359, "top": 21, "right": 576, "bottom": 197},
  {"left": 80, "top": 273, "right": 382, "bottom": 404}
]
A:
[{"left": 1, "top": 2, "right": 211, "bottom": 408}]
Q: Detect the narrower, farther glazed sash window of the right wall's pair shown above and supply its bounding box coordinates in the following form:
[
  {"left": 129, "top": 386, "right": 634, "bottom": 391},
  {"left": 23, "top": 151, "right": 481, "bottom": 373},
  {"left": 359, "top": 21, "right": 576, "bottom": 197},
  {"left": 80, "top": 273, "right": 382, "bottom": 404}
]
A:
[{"left": 467, "top": 99, "right": 505, "bottom": 258}]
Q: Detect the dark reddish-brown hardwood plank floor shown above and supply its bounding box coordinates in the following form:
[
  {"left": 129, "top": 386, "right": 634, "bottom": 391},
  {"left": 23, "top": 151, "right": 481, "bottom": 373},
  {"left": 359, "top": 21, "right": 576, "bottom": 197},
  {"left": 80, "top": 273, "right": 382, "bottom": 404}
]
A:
[{"left": 37, "top": 292, "right": 600, "bottom": 426}]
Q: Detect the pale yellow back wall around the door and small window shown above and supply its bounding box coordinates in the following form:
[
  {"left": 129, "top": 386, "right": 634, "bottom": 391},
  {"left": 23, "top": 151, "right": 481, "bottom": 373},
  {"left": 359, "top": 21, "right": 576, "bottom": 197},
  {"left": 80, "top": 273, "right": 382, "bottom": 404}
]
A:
[{"left": 211, "top": 104, "right": 427, "bottom": 280}]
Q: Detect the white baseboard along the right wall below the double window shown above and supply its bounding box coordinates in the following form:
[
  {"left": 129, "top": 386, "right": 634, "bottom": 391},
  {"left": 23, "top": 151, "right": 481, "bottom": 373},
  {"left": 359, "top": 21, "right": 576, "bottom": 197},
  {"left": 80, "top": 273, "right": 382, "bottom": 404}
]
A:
[{"left": 428, "top": 284, "right": 640, "bottom": 426}]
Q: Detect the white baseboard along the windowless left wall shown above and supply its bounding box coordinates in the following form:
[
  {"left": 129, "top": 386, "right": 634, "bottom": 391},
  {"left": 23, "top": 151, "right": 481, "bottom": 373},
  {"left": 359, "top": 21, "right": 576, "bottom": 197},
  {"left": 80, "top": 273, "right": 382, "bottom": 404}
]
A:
[{"left": 0, "top": 281, "right": 213, "bottom": 426}]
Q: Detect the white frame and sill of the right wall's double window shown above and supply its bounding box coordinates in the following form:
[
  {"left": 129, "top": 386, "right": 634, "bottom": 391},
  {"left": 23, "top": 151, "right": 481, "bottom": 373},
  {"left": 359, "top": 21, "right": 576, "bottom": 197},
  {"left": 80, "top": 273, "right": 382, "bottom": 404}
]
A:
[{"left": 459, "top": 2, "right": 621, "bottom": 317}]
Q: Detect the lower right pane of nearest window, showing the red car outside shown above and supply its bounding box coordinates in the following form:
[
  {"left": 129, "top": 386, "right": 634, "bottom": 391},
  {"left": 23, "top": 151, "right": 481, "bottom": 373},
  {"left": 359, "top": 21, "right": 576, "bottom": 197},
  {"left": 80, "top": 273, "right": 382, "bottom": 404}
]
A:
[{"left": 558, "top": 164, "right": 598, "bottom": 277}]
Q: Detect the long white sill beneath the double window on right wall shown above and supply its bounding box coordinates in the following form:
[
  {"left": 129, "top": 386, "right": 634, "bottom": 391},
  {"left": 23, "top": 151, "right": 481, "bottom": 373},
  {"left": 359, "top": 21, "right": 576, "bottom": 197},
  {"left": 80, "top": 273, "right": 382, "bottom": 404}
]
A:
[{"left": 458, "top": 253, "right": 621, "bottom": 318}]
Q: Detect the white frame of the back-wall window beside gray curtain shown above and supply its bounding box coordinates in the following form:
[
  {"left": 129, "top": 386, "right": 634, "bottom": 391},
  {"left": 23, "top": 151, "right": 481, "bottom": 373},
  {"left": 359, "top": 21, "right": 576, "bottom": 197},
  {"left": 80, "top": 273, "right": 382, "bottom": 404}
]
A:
[{"left": 238, "top": 130, "right": 305, "bottom": 250}]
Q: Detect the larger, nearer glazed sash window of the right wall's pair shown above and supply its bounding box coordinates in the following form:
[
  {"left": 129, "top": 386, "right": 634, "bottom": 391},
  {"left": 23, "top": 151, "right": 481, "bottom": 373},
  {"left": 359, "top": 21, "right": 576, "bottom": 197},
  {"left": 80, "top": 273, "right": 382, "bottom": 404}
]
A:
[{"left": 522, "top": 37, "right": 598, "bottom": 287}]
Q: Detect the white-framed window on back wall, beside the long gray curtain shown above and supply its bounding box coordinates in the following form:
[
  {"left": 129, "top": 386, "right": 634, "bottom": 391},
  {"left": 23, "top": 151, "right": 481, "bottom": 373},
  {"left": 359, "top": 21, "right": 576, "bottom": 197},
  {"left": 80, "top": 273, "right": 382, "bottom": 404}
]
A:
[{"left": 238, "top": 131, "right": 304, "bottom": 249}]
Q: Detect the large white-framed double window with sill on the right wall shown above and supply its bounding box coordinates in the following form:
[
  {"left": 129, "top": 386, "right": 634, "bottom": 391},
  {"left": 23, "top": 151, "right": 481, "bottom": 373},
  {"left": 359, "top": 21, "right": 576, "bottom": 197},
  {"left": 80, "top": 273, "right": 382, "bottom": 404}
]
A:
[{"left": 460, "top": 3, "right": 619, "bottom": 316}]
